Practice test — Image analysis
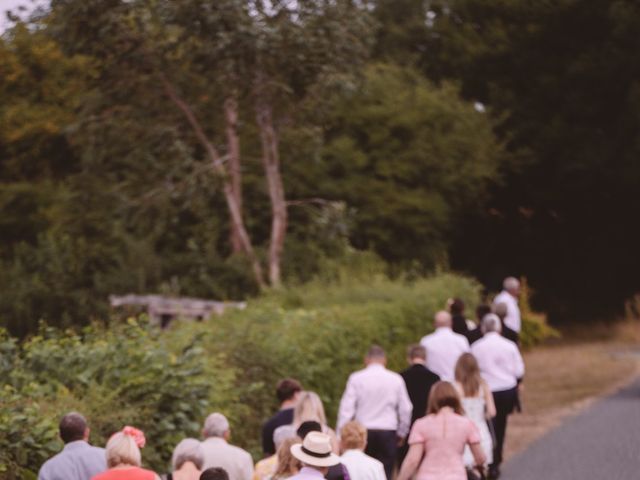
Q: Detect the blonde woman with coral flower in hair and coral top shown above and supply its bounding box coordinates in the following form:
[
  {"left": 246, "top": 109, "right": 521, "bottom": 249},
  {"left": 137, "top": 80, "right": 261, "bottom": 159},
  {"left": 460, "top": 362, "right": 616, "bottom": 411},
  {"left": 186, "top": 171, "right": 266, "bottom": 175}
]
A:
[{"left": 91, "top": 426, "right": 160, "bottom": 480}]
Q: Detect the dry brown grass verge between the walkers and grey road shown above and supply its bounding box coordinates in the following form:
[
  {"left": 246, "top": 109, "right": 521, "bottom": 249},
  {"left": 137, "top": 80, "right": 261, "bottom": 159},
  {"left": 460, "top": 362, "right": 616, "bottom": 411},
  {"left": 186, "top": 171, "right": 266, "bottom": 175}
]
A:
[{"left": 505, "top": 342, "right": 640, "bottom": 461}]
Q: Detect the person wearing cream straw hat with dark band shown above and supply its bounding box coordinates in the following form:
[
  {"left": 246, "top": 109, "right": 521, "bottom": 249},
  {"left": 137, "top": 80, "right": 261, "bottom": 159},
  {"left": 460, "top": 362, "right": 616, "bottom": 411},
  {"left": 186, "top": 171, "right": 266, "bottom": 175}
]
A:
[{"left": 289, "top": 432, "right": 340, "bottom": 480}]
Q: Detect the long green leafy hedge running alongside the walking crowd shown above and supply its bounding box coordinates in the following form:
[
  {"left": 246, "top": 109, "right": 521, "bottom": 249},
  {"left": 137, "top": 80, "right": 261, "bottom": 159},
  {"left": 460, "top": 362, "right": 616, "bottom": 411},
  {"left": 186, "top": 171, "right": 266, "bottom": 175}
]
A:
[{"left": 0, "top": 270, "right": 556, "bottom": 472}]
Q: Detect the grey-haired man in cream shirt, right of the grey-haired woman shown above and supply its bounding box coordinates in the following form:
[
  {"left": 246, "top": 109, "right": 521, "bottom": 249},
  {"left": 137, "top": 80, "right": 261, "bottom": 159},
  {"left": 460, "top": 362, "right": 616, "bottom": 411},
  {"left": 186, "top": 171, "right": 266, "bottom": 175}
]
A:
[{"left": 202, "top": 413, "right": 253, "bottom": 480}]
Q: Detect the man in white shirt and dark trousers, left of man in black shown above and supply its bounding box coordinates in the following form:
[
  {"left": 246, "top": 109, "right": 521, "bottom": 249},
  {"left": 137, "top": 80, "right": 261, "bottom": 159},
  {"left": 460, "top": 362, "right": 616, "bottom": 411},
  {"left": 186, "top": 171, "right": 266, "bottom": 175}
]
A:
[{"left": 337, "top": 345, "right": 413, "bottom": 480}]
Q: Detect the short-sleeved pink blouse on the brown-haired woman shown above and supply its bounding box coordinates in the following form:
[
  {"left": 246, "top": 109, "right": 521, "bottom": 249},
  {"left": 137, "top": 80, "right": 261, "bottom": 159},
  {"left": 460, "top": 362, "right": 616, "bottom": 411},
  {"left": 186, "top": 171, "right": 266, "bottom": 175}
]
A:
[{"left": 409, "top": 407, "right": 480, "bottom": 480}]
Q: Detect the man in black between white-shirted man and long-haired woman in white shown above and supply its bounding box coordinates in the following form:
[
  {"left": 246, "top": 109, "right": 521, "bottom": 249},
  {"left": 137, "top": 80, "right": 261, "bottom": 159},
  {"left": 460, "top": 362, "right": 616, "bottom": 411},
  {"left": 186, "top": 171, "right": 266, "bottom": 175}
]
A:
[{"left": 398, "top": 344, "right": 440, "bottom": 465}]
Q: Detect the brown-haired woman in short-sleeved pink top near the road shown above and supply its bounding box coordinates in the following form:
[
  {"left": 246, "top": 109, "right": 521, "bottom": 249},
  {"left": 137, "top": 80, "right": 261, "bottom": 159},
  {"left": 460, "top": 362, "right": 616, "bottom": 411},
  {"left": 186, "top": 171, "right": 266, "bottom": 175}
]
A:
[{"left": 397, "top": 382, "right": 485, "bottom": 480}]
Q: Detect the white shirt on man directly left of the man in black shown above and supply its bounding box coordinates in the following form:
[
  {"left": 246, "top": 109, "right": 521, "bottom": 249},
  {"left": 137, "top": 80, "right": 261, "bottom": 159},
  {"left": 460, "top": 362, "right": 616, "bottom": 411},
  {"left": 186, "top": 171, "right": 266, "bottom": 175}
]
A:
[{"left": 337, "top": 363, "right": 413, "bottom": 437}]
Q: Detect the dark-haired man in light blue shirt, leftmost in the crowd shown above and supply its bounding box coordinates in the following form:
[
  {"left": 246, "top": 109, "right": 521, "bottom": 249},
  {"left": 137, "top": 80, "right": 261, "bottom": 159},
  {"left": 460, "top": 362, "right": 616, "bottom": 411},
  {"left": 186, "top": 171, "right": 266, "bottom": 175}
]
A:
[{"left": 38, "top": 412, "right": 107, "bottom": 480}]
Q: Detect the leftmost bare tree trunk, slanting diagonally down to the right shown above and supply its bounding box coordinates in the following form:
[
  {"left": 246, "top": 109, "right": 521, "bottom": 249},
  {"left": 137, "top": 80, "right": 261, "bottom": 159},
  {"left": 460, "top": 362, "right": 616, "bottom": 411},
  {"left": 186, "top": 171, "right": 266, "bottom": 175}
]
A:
[{"left": 162, "top": 77, "right": 265, "bottom": 288}]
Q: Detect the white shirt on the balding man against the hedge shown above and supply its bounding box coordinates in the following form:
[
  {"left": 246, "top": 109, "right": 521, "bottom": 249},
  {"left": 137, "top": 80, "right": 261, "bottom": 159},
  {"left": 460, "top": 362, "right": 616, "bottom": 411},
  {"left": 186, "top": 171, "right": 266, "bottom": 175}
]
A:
[{"left": 420, "top": 327, "right": 469, "bottom": 382}]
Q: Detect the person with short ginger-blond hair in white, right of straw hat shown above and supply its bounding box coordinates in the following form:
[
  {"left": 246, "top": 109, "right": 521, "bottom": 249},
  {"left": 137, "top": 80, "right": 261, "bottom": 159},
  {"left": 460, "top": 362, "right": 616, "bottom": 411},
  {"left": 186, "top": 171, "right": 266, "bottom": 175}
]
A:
[{"left": 340, "top": 420, "right": 387, "bottom": 480}]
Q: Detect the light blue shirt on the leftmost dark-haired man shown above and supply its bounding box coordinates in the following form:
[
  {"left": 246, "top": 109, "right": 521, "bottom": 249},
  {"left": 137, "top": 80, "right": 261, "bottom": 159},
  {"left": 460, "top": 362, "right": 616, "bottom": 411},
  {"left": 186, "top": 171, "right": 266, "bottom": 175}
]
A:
[{"left": 38, "top": 440, "right": 107, "bottom": 480}]
